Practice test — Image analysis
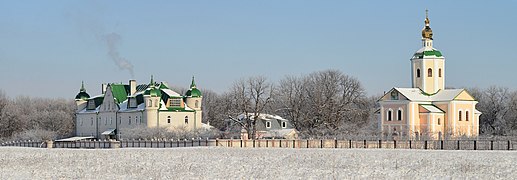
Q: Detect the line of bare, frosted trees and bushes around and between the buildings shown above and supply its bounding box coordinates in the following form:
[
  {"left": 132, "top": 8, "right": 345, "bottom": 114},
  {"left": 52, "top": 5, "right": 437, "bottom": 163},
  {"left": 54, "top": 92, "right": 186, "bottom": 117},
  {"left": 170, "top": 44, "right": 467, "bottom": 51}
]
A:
[{"left": 0, "top": 70, "right": 517, "bottom": 140}]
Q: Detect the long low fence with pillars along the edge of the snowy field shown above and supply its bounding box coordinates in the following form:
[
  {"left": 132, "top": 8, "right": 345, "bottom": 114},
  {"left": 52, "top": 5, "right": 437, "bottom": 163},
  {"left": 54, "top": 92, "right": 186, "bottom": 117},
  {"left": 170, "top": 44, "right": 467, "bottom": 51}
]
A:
[{"left": 1, "top": 139, "right": 517, "bottom": 150}]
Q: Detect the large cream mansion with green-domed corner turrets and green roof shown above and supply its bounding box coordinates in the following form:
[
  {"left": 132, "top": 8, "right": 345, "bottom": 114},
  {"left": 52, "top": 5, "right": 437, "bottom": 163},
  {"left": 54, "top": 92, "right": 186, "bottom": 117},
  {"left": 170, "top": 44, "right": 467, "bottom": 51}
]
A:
[{"left": 75, "top": 77, "right": 203, "bottom": 139}]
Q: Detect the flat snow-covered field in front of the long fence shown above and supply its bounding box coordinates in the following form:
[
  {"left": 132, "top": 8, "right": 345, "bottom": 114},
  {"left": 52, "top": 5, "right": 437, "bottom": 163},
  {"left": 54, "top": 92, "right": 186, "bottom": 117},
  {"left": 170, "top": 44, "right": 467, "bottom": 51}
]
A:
[{"left": 0, "top": 147, "right": 517, "bottom": 179}]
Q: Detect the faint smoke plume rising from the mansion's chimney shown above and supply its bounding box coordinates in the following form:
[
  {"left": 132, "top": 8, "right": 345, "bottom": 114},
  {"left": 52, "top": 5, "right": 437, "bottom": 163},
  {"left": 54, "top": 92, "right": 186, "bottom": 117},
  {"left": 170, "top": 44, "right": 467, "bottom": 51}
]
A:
[{"left": 103, "top": 32, "right": 135, "bottom": 78}]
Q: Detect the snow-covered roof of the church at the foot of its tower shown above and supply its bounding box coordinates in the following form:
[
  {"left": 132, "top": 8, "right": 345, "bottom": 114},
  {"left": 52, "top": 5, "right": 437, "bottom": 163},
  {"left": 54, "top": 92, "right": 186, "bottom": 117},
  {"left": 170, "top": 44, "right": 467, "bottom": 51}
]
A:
[{"left": 394, "top": 88, "right": 464, "bottom": 101}]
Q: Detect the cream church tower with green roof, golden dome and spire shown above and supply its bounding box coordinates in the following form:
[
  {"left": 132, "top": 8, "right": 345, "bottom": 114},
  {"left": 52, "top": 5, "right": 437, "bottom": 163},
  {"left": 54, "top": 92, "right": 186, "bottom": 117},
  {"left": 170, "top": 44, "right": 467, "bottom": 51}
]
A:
[{"left": 411, "top": 10, "right": 445, "bottom": 94}]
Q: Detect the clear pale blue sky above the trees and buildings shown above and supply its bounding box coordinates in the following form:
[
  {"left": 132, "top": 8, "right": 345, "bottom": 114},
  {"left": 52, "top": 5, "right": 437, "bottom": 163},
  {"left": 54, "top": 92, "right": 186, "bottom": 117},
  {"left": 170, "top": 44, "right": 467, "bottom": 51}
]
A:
[{"left": 0, "top": 0, "right": 517, "bottom": 98}]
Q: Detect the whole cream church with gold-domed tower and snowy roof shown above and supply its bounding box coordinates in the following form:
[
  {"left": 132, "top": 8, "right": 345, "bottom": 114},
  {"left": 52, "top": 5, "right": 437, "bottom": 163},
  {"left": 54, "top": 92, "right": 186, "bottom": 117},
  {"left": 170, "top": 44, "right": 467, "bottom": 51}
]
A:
[{"left": 379, "top": 12, "right": 481, "bottom": 139}]
